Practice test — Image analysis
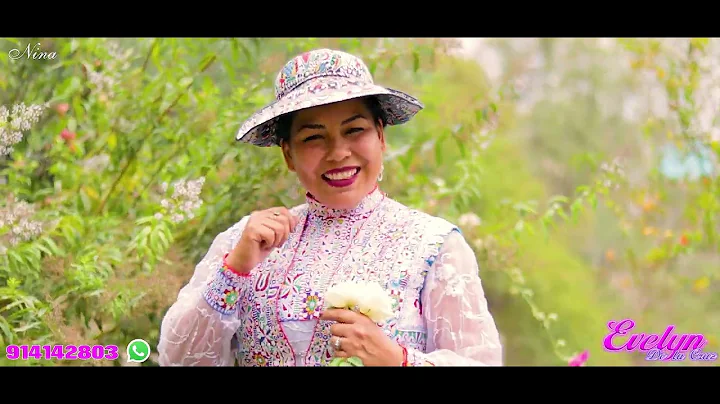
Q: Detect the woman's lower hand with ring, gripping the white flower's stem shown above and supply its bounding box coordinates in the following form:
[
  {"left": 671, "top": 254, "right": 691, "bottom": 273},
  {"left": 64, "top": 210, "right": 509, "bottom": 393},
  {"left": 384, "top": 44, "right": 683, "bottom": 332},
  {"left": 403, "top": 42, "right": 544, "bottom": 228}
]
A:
[{"left": 320, "top": 309, "right": 404, "bottom": 366}]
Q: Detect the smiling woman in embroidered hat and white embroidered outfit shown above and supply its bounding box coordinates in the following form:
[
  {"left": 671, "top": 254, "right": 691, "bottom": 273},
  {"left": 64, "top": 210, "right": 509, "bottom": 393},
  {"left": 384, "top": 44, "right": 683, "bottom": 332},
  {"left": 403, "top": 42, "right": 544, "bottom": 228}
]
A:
[{"left": 158, "top": 49, "right": 502, "bottom": 366}]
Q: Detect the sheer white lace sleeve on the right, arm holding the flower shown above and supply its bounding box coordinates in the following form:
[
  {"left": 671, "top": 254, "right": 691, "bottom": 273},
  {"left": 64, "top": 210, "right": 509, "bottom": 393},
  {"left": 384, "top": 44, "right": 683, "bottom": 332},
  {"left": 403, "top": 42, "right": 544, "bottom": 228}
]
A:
[{"left": 408, "top": 232, "right": 503, "bottom": 366}]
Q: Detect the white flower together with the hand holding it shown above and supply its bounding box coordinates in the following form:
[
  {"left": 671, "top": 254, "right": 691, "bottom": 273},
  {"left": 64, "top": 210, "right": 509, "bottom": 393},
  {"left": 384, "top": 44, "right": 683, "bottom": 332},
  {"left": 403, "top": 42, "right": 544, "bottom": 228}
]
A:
[{"left": 320, "top": 283, "right": 403, "bottom": 366}]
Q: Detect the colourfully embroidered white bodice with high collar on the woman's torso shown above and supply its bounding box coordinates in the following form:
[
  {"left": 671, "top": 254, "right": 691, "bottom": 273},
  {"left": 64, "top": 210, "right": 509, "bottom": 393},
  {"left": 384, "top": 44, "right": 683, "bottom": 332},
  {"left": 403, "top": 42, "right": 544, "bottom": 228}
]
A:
[{"left": 229, "top": 191, "right": 457, "bottom": 366}]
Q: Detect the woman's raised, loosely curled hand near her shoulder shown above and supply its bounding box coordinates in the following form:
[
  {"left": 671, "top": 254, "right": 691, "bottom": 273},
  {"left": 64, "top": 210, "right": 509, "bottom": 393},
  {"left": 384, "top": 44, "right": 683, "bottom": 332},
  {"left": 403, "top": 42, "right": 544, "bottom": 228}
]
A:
[{"left": 227, "top": 207, "right": 298, "bottom": 274}]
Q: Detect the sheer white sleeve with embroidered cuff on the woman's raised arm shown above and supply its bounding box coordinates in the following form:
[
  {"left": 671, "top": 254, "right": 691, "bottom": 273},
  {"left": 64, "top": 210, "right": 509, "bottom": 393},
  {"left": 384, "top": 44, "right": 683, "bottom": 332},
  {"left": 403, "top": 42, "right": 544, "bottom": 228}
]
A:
[{"left": 158, "top": 217, "right": 250, "bottom": 366}]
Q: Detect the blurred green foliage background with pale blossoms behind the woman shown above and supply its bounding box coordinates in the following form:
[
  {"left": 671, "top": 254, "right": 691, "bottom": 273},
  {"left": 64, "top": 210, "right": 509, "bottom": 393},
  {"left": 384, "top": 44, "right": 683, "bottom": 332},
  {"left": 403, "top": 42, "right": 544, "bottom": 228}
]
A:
[{"left": 0, "top": 38, "right": 720, "bottom": 366}]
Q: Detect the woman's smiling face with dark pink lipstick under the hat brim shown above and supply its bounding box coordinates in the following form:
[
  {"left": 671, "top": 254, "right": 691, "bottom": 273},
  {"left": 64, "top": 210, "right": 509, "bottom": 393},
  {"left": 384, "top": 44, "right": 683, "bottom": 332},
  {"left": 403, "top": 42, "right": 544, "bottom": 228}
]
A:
[{"left": 282, "top": 99, "right": 385, "bottom": 209}]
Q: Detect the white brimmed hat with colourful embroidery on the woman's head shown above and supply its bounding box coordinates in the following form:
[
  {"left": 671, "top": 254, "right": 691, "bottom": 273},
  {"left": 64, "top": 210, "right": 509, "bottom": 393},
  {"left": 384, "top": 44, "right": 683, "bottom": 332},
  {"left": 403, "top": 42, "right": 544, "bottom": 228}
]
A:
[{"left": 235, "top": 49, "right": 423, "bottom": 147}]
